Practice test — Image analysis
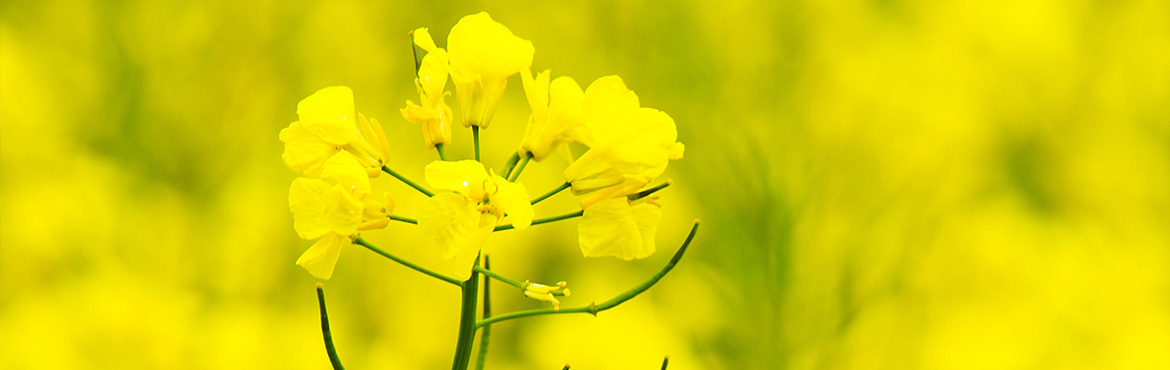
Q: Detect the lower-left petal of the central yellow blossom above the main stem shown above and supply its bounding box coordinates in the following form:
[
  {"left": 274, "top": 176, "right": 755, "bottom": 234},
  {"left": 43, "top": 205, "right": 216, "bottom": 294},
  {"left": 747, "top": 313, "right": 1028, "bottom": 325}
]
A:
[{"left": 419, "top": 193, "right": 482, "bottom": 259}]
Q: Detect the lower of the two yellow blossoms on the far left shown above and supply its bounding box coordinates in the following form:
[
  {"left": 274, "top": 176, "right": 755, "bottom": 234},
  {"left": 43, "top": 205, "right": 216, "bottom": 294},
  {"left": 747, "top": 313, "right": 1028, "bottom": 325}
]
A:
[{"left": 289, "top": 151, "right": 394, "bottom": 279}]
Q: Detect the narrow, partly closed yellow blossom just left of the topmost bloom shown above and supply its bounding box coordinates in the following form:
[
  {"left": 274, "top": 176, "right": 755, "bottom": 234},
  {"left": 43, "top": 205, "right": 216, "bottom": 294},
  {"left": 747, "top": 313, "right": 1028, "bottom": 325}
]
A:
[{"left": 401, "top": 28, "right": 452, "bottom": 148}]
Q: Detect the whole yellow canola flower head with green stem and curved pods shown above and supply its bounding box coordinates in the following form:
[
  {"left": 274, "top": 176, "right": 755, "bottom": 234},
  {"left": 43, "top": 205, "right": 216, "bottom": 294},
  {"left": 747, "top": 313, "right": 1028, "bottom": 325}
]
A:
[{"left": 280, "top": 13, "right": 698, "bottom": 370}]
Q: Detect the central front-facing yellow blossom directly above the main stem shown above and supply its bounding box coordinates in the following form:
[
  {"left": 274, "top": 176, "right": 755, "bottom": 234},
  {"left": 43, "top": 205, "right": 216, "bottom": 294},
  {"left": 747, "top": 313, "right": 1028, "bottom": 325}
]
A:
[{"left": 419, "top": 160, "right": 532, "bottom": 279}]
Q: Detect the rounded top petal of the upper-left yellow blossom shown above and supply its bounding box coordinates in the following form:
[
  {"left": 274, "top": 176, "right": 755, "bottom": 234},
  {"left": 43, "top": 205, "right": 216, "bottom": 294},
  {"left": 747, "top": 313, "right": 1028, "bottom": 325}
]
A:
[{"left": 296, "top": 87, "right": 362, "bottom": 145}]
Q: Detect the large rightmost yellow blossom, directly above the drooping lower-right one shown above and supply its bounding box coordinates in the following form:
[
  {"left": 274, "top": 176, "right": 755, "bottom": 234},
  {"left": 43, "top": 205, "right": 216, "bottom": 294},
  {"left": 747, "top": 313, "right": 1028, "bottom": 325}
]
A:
[{"left": 564, "top": 76, "right": 683, "bottom": 208}]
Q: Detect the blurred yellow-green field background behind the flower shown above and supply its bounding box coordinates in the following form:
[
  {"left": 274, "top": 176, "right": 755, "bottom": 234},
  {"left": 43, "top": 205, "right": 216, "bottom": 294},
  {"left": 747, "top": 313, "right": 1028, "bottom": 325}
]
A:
[{"left": 0, "top": 0, "right": 1170, "bottom": 369}]
